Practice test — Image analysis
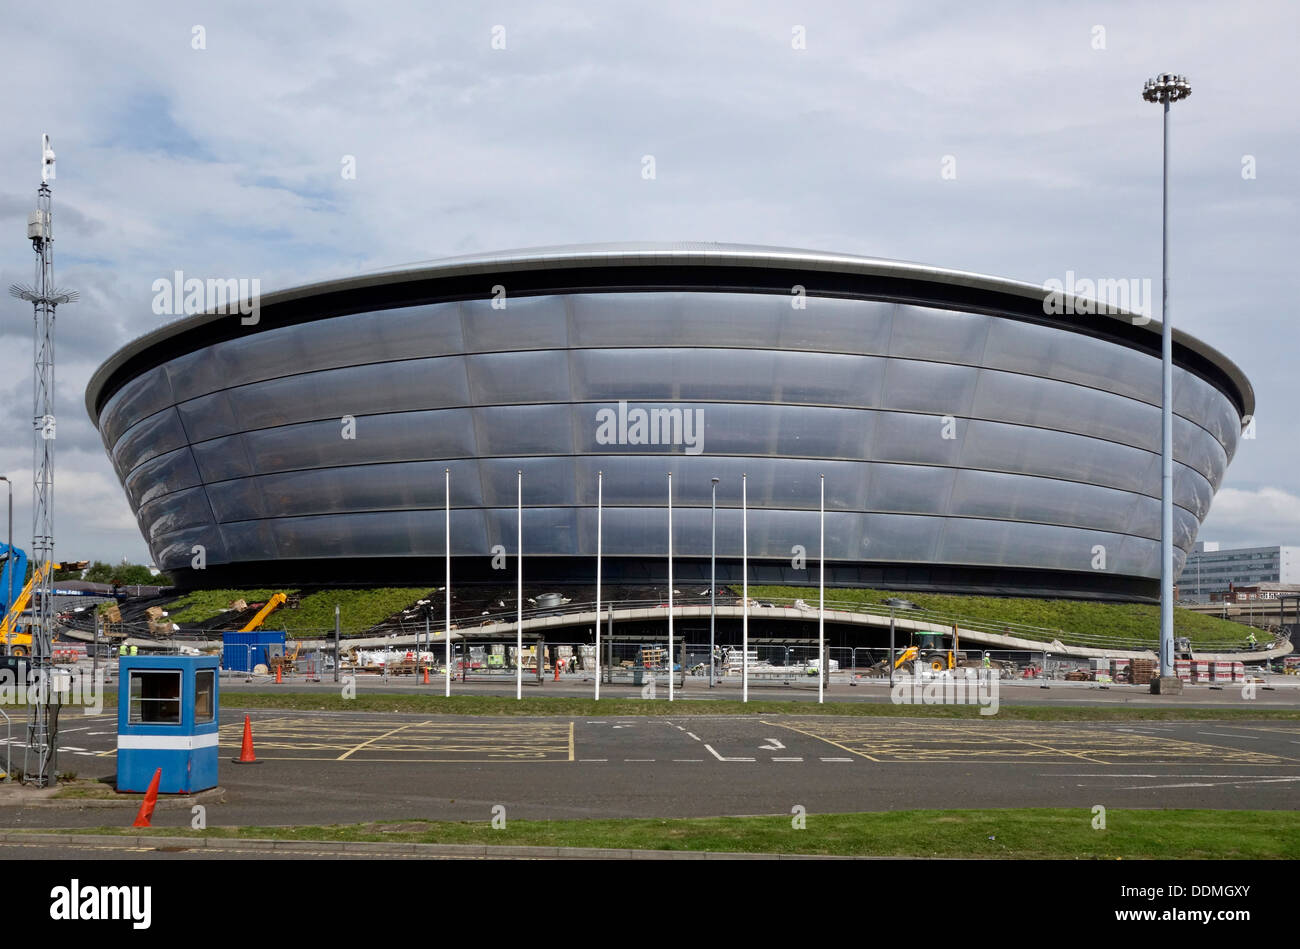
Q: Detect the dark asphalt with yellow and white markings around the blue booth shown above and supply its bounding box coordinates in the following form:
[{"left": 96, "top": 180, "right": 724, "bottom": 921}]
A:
[{"left": 0, "top": 697, "right": 1300, "bottom": 828}]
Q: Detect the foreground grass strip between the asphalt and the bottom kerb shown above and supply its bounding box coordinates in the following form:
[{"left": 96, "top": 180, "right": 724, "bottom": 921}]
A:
[{"left": 15, "top": 807, "right": 1300, "bottom": 859}]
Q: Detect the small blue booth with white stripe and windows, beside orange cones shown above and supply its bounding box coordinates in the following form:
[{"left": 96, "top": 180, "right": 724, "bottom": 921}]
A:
[{"left": 117, "top": 655, "right": 220, "bottom": 794}]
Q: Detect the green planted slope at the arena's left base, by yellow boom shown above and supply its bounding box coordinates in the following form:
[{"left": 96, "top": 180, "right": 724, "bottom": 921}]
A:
[{"left": 169, "top": 586, "right": 429, "bottom": 636}]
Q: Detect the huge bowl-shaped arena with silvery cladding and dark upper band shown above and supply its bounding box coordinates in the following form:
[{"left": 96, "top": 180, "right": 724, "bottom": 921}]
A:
[{"left": 86, "top": 244, "right": 1255, "bottom": 598}]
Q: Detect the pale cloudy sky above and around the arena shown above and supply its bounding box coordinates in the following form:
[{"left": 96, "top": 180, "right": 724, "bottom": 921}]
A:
[{"left": 0, "top": 0, "right": 1300, "bottom": 560}]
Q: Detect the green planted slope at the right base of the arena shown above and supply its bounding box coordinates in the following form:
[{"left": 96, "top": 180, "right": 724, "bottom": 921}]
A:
[{"left": 749, "top": 586, "right": 1262, "bottom": 645}]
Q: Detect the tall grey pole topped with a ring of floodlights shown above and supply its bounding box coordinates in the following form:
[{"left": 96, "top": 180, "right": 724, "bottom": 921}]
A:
[{"left": 1141, "top": 66, "right": 1192, "bottom": 693}]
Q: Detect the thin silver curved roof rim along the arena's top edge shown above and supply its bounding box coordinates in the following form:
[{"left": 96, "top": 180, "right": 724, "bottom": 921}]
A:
[{"left": 86, "top": 242, "right": 1255, "bottom": 428}]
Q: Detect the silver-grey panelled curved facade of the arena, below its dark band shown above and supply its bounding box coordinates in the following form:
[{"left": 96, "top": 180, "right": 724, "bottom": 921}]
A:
[{"left": 100, "top": 291, "right": 1240, "bottom": 579}]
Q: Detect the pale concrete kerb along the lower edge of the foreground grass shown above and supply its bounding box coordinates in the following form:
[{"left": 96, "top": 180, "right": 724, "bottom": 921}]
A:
[{"left": 0, "top": 831, "right": 863, "bottom": 861}]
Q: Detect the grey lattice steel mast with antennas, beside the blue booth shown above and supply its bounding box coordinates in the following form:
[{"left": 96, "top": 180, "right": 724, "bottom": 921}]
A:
[{"left": 9, "top": 135, "right": 77, "bottom": 788}]
